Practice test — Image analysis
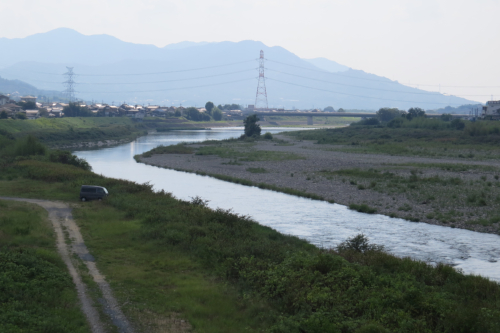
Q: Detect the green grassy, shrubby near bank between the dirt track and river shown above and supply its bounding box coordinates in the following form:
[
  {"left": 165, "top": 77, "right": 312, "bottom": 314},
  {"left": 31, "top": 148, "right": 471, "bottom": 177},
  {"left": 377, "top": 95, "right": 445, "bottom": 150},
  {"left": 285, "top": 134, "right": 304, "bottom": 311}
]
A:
[{"left": 0, "top": 131, "right": 500, "bottom": 333}]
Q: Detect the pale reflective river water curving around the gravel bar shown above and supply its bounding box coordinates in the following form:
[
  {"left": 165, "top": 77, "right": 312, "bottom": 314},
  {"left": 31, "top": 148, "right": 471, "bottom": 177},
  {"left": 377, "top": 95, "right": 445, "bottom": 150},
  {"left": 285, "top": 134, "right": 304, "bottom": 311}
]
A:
[{"left": 74, "top": 128, "right": 500, "bottom": 282}]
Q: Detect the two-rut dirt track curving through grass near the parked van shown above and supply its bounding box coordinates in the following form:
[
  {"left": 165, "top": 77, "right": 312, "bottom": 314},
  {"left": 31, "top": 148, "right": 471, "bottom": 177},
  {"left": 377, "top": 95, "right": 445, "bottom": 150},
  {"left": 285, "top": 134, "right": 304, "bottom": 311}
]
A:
[{"left": 0, "top": 197, "right": 133, "bottom": 333}]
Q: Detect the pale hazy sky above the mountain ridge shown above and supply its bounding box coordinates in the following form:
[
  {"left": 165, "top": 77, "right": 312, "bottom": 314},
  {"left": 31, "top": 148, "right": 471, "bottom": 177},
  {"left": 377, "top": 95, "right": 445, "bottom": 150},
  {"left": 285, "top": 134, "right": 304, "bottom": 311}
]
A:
[{"left": 0, "top": 0, "right": 500, "bottom": 101}]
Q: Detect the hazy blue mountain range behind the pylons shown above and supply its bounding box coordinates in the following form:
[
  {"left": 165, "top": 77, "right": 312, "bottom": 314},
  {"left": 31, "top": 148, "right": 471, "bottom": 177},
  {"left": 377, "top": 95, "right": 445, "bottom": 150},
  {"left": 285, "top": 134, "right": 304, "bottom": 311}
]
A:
[{"left": 0, "top": 28, "right": 477, "bottom": 110}]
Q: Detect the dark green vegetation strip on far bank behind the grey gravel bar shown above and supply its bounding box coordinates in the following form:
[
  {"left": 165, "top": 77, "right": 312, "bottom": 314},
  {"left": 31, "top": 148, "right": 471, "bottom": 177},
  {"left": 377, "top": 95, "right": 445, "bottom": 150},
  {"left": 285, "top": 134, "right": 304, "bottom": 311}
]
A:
[{"left": 286, "top": 117, "right": 500, "bottom": 160}]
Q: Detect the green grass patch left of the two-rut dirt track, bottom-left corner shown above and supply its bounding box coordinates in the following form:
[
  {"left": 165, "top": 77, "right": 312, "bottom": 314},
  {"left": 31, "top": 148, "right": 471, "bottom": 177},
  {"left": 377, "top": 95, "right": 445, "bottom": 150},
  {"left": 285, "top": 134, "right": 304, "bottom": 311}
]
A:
[{"left": 0, "top": 200, "right": 90, "bottom": 333}]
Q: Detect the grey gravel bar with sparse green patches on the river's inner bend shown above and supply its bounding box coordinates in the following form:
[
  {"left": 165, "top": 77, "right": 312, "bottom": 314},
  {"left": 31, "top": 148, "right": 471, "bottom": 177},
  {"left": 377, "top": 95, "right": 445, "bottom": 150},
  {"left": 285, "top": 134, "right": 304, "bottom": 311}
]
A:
[{"left": 138, "top": 135, "right": 500, "bottom": 234}]
